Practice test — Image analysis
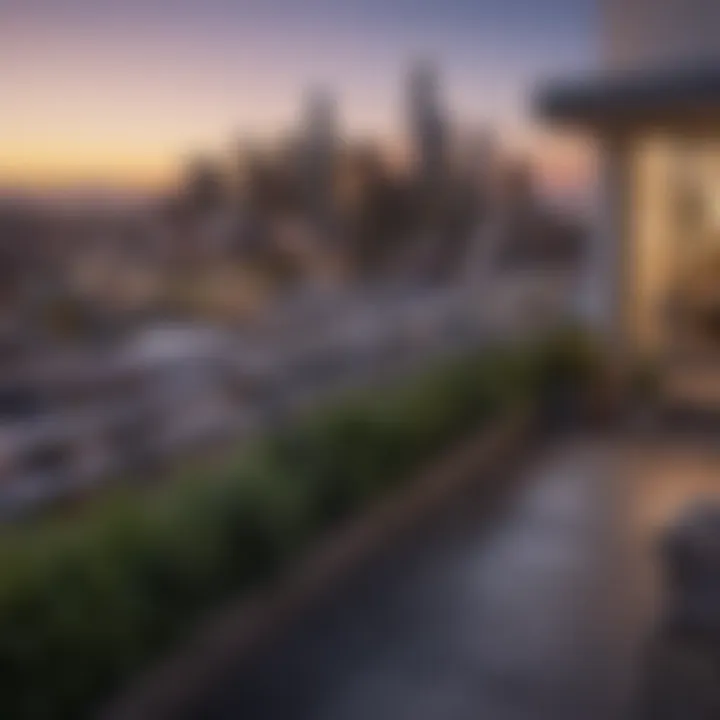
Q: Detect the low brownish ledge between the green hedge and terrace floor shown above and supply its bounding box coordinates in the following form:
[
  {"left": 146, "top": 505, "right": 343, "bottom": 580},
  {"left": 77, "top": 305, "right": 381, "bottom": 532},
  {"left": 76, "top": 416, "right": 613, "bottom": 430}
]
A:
[{"left": 99, "top": 409, "right": 534, "bottom": 720}]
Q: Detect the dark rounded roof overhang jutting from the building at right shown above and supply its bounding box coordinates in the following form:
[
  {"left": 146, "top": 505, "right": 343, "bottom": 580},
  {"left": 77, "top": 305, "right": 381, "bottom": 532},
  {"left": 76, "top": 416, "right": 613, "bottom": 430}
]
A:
[{"left": 536, "top": 65, "right": 720, "bottom": 132}]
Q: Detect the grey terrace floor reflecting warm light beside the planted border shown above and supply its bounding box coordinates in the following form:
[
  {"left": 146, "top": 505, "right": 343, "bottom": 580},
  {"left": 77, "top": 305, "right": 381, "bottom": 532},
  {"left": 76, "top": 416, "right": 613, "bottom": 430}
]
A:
[{"left": 191, "top": 438, "right": 720, "bottom": 720}]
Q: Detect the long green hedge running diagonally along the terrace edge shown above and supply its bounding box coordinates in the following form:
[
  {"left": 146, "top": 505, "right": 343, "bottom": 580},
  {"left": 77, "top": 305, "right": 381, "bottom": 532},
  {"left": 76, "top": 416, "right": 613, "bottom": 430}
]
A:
[{"left": 0, "top": 351, "right": 564, "bottom": 720}]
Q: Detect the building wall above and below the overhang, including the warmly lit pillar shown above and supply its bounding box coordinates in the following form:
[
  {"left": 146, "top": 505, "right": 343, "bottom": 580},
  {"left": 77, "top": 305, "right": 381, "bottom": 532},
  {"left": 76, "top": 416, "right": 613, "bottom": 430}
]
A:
[{"left": 588, "top": 0, "right": 720, "bottom": 353}]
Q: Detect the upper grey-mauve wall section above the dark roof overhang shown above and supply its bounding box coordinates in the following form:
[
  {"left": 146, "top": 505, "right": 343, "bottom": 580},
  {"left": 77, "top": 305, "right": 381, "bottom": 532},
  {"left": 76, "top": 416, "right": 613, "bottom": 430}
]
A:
[{"left": 600, "top": 0, "right": 720, "bottom": 72}]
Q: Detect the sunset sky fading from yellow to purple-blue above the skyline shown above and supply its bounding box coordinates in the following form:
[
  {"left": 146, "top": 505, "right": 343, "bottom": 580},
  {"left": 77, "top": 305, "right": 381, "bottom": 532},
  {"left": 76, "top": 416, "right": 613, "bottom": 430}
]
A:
[{"left": 0, "top": 0, "right": 598, "bottom": 194}]
